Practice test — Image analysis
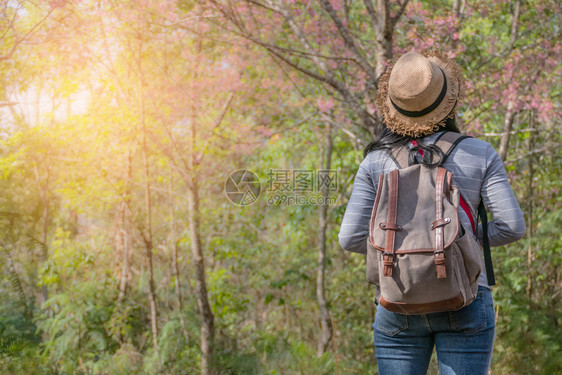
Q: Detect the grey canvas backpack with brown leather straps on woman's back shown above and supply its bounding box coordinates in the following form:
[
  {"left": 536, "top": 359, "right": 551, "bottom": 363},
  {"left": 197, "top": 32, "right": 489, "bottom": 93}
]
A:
[{"left": 367, "top": 132, "right": 494, "bottom": 314}]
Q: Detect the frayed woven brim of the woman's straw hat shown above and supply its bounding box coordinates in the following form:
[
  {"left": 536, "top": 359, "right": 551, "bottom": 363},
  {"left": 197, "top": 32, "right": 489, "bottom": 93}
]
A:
[{"left": 376, "top": 50, "right": 466, "bottom": 138}]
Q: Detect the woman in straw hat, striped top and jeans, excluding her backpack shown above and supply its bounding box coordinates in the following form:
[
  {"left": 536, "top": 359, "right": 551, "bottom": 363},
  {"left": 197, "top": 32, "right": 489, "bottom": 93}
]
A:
[{"left": 339, "top": 52, "right": 525, "bottom": 375}]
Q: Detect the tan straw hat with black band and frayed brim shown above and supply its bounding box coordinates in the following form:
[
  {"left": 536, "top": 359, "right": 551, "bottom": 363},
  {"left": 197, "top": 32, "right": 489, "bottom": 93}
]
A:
[{"left": 376, "top": 51, "right": 465, "bottom": 138}]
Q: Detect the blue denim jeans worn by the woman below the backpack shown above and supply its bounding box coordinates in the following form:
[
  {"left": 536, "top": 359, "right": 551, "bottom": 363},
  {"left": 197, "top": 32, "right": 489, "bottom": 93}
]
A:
[{"left": 373, "top": 286, "right": 496, "bottom": 375}]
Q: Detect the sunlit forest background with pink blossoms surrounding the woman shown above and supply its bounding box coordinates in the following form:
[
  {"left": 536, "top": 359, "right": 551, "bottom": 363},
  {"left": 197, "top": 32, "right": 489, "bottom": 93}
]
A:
[{"left": 0, "top": 0, "right": 562, "bottom": 374}]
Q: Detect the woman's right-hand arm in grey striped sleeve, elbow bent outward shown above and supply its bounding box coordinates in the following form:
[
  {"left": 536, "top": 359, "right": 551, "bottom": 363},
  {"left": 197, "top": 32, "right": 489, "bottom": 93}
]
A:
[{"left": 478, "top": 145, "right": 526, "bottom": 246}]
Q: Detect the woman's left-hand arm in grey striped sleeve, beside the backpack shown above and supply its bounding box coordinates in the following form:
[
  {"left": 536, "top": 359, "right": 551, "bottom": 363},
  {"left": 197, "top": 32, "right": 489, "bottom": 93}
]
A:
[{"left": 338, "top": 158, "right": 377, "bottom": 254}]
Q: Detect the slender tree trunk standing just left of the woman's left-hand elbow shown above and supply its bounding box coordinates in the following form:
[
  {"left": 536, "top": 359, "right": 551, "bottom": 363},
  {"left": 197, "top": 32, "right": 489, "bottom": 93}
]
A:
[{"left": 316, "top": 122, "right": 333, "bottom": 357}]
